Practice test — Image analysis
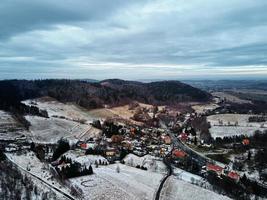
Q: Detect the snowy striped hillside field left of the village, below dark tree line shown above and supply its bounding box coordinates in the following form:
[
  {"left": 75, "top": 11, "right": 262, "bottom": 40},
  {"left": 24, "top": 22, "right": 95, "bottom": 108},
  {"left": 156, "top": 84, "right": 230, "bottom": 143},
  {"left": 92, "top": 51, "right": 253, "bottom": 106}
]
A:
[{"left": 25, "top": 115, "right": 91, "bottom": 143}]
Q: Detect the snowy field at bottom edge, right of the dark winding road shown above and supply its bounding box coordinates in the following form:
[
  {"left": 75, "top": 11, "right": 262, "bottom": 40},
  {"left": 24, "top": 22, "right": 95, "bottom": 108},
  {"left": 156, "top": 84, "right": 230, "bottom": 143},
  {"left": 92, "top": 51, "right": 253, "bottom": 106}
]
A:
[{"left": 160, "top": 176, "right": 230, "bottom": 200}]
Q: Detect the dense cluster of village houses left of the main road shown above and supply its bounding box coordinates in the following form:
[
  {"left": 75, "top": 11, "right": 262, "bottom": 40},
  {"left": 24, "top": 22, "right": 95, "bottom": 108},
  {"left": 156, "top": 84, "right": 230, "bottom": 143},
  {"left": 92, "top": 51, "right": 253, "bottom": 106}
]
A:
[{"left": 74, "top": 126, "right": 171, "bottom": 162}]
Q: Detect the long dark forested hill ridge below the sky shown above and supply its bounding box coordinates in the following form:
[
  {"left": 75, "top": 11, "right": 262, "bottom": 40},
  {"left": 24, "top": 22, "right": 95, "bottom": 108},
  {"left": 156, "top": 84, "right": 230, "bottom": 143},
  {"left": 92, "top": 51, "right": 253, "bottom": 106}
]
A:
[{"left": 0, "top": 79, "right": 211, "bottom": 109}]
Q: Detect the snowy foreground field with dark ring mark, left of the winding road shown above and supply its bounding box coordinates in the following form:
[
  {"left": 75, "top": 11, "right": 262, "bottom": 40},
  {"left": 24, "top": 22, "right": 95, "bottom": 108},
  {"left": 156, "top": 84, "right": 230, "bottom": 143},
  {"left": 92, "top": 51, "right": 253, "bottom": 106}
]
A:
[{"left": 71, "top": 164, "right": 163, "bottom": 200}]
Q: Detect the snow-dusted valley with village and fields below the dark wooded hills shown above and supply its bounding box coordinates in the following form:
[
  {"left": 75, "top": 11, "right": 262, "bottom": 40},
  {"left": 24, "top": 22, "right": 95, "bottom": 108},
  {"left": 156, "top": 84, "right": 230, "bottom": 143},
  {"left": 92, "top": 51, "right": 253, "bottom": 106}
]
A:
[{"left": 0, "top": 81, "right": 267, "bottom": 200}]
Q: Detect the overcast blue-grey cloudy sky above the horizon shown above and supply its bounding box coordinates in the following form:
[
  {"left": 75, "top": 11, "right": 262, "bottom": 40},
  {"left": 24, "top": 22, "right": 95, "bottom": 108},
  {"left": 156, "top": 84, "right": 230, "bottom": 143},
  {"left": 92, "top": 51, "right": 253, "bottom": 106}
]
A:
[{"left": 0, "top": 0, "right": 267, "bottom": 79}]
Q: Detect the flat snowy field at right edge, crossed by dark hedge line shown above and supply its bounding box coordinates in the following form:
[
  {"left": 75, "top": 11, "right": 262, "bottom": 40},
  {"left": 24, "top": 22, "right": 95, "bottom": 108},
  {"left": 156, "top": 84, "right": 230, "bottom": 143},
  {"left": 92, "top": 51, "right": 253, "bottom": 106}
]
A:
[{"left": 207, "top": 114, "right": 267, "bottom": 138}]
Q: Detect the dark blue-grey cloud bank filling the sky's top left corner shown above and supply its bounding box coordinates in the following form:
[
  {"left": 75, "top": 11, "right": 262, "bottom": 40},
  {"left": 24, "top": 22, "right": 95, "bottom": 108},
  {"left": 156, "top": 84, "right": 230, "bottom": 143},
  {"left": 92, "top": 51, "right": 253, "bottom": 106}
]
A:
[{"left": 0, "top": 0, "right": 135, "bottom": 38}]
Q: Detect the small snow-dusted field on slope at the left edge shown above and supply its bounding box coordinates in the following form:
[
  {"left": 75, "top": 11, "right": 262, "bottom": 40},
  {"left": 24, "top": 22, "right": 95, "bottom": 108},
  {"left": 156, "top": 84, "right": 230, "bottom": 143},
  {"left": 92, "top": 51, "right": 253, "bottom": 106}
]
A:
[{"left": 0, "top": 110, "right": 25, "bottom": 140}]
